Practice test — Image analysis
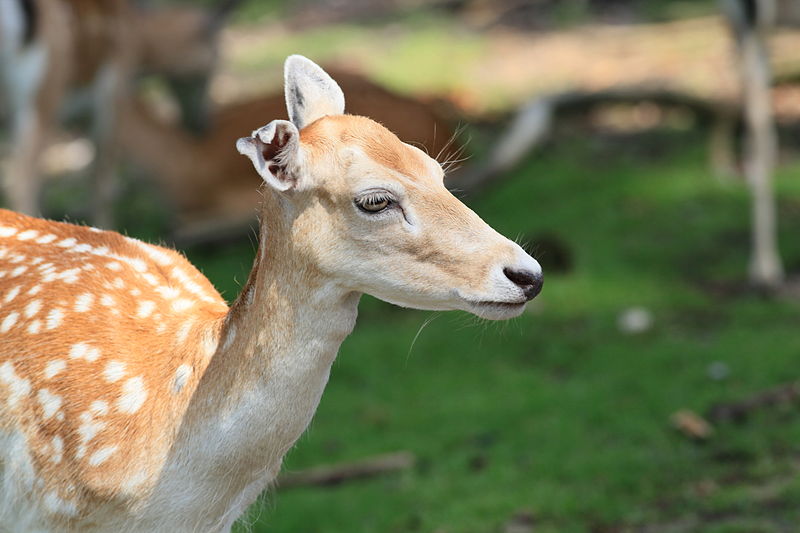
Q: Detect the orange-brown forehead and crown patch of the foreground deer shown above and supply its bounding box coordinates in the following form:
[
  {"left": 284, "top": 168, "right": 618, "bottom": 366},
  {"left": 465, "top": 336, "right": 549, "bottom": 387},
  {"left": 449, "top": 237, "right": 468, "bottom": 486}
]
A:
[{"left": 300, "top": 115, "right": 442, "bottom": 182}]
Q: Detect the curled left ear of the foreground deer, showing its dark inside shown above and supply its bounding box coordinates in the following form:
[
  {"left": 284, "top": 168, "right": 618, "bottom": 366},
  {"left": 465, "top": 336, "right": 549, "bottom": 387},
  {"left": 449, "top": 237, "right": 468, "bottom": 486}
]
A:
[{"left": 236, "top": 120, "right": 300, "bottom": 191}]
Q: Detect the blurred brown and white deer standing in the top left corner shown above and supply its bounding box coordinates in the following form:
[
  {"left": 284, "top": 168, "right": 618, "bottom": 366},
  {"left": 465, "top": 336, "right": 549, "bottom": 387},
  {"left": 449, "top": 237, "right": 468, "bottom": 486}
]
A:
[{"left": 0, "top": 0, "right": 238, "bottom": 226}]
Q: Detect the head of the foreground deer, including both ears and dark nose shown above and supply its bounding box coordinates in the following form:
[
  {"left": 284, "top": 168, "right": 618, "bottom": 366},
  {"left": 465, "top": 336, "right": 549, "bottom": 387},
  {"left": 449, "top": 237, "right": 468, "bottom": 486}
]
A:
[{"left": 237, "top": 55, "right": 542, "bottom": 319}]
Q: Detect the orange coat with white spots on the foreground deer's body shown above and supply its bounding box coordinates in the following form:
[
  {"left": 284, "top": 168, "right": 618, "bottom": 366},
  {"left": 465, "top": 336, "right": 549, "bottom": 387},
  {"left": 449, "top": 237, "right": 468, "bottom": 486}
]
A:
[{"left": 0, "top": 210, "right": 228, "bottom": 520}]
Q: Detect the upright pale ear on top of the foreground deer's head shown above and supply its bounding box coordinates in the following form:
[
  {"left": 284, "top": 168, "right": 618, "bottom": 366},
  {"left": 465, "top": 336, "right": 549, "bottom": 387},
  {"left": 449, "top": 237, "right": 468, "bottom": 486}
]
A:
[{"left": 283, "top": 55, "right": 344, "bottom": 130}]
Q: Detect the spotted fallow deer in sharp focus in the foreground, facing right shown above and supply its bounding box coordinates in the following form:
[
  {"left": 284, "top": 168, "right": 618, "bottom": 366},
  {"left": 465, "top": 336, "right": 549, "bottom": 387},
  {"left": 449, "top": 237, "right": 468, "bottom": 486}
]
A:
[{"left": 0, "top": 56, "right": 542, "bottom": 533}]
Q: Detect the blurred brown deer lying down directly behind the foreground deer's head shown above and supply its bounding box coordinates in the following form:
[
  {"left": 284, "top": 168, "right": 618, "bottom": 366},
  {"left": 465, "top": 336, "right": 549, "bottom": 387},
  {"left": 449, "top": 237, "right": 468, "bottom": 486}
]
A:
[{"left": 120, "top": 68, "right": 463, "bottom": 242}]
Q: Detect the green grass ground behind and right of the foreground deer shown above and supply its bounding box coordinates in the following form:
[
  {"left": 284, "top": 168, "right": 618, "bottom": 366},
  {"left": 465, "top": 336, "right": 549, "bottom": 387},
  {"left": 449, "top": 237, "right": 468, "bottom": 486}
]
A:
[{"left": 170, "top": 130, "right": 800, "bottom": 533}]
